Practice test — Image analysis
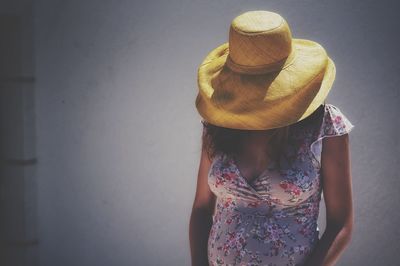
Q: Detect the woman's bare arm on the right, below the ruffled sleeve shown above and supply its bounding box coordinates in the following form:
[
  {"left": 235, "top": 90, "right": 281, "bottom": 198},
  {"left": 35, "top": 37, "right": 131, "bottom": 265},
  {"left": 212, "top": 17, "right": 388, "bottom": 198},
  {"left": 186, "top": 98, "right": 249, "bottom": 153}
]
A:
[{"left": 304, "top": 134, "right": 353, "bottom": 266}]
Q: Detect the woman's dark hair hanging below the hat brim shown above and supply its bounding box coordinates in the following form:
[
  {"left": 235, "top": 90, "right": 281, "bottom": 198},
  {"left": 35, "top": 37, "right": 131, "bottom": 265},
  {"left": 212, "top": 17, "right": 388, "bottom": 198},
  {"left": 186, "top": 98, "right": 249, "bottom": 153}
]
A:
[{"left": 202, "top": 104, "right": 324, "bottom": 168}]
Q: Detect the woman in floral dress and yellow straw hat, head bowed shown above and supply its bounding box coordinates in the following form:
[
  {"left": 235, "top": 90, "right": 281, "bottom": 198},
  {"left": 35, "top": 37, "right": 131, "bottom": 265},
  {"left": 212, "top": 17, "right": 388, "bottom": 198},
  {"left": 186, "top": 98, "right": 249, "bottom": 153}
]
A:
[{"left": 189, "top": 11, "right": 354, "bottom": 266}]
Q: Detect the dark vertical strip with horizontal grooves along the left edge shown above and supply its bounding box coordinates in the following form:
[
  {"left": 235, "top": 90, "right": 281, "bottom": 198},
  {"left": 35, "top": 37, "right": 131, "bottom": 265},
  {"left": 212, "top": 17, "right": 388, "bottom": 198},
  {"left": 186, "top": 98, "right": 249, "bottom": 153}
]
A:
[{"left": 0, "top": 0, "right": 39, "bottom": 266}]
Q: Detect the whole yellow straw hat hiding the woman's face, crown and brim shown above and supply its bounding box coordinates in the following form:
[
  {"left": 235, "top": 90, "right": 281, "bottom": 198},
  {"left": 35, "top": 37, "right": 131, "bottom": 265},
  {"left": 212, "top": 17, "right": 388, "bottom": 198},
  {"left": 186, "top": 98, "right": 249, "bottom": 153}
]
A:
[{"left": 195, "top": 10, "right": 336, "bottom": 130}]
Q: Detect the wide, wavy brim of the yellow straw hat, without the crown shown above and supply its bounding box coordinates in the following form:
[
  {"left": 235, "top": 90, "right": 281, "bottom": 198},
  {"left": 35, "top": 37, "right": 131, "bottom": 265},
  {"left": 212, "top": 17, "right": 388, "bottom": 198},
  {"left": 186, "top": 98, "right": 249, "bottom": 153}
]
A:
[{"left": 195, "top": 38, "right": 336, "bottom": 130}]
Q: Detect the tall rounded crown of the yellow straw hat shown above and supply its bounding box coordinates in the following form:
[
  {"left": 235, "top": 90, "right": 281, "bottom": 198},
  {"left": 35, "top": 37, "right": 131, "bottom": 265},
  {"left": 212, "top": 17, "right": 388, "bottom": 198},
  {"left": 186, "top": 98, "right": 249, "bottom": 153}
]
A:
[{"left": 228, "top": 10, "right": 292, "bottom": 72}]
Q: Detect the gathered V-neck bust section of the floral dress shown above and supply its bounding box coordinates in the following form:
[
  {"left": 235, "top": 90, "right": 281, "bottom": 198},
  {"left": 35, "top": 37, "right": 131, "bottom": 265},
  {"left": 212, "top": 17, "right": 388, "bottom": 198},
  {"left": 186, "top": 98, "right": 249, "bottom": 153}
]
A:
[{"left": 208, "top": 152, "right": 321, "bottom": 206}]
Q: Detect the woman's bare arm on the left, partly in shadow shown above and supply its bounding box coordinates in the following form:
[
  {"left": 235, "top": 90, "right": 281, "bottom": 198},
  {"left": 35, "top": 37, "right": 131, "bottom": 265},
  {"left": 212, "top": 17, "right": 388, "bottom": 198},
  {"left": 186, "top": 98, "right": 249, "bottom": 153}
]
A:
[{"left": 189, "top": 137, "right": 216, "bottom": 266}]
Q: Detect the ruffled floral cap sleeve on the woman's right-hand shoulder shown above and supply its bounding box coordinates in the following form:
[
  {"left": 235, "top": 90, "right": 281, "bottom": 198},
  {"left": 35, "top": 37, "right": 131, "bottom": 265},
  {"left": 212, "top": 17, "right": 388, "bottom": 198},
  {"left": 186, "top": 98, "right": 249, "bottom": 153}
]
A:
[{"left": 310, "top": 103, "right": 354, "bottom": 168}]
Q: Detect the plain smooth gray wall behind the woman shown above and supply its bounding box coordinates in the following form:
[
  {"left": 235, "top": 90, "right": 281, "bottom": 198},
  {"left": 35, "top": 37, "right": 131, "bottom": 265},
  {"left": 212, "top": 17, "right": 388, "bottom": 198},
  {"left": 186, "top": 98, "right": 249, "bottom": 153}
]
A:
[{"left": 34, "top": 0, "right": 400, "bottom": 266}]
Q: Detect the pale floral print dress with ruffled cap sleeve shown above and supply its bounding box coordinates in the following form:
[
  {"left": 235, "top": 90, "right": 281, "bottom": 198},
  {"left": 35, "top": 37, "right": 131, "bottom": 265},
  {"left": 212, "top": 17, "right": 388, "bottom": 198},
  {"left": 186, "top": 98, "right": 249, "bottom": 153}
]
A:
[{"left": 201, "top": 103, "right": 354, "bottom": 266}]
